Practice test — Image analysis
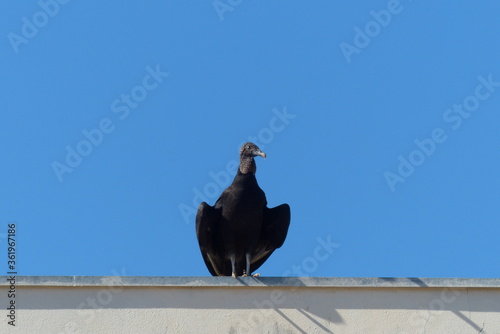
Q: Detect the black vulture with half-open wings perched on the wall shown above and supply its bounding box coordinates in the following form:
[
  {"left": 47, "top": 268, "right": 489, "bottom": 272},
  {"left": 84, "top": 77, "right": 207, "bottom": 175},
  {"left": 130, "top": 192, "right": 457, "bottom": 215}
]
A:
[{"left": 196, "top": 142, "right": 291, "bottom": 278}]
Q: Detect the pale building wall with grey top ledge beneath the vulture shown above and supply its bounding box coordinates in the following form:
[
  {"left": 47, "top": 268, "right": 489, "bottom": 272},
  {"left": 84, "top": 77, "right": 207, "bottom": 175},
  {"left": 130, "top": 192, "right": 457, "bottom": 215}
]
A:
[{"left": 0, "top": 277, "right": 500, "bottom": 334}]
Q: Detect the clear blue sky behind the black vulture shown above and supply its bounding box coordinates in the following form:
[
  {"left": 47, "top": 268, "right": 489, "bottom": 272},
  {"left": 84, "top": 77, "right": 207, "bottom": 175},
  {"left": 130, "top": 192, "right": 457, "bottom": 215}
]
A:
[{"left": 0, "top": 0, "right": 500, "bottom": 277}]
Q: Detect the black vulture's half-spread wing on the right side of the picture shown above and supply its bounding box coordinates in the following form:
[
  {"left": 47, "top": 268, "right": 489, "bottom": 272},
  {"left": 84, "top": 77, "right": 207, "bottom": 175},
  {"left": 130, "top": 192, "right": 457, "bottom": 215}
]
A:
[{"left": 250, "top": 204, "right": 290, "bottom": 272}]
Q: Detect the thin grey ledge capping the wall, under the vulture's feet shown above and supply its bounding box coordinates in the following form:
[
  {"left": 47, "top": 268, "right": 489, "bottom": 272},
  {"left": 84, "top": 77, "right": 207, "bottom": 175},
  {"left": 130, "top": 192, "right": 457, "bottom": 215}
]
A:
[{"left": 0, "top": 276, "right": 500, "bottom": 288}]
